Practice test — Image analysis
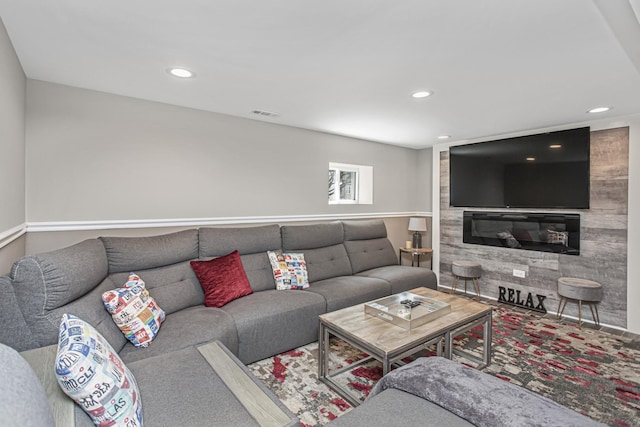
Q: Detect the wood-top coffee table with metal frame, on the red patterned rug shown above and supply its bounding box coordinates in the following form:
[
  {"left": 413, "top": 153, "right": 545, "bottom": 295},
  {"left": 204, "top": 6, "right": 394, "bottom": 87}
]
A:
[{"left": 318, "top": 288, "right": 492, "bottom": 406}]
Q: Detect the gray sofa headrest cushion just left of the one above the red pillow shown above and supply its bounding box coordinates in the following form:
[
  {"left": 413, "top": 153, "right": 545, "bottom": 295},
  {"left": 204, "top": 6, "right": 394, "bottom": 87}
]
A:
[{"left": 100, "top": 230, "right": 198, "bottom": 274}]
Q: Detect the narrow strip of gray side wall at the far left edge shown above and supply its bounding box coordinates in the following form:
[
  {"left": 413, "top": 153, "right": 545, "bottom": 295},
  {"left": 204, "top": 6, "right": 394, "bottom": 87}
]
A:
[{"left": 0, "top": 17, "right": 26, "bottom": 272}]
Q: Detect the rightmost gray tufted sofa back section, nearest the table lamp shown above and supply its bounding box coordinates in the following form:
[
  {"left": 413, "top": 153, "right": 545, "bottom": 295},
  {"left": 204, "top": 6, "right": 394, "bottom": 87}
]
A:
[{"left": 342, "top": 220, "right": 398, "bottom": 274}]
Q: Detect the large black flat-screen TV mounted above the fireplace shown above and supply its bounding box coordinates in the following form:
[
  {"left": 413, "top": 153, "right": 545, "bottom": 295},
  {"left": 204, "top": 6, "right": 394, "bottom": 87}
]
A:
[{"left": 449, "top": 127, "right": 590, "bottom": 209}]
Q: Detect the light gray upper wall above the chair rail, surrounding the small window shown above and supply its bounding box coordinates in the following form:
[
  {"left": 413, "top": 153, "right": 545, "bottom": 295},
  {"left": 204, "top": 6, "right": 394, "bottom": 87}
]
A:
[{"left": 26, "top": 80, "right": 418, "bottom": 224}]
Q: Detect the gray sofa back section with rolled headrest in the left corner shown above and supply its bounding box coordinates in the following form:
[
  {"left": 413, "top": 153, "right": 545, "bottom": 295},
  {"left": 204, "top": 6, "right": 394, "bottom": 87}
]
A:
[{"left": 11, "top": 239, "right": 126, "bottom": 351}]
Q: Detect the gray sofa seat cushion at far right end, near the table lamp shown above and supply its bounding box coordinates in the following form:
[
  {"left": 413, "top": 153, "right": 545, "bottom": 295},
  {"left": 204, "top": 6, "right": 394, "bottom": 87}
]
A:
[{"left": 358, "top": 265, "right": 438, "bottom": 294}]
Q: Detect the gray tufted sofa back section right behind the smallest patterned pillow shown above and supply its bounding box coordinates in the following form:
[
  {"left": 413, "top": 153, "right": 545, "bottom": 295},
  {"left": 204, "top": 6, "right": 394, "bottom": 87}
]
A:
[{"left": 281, "top": 221, "right": 352, "bottom": 286}]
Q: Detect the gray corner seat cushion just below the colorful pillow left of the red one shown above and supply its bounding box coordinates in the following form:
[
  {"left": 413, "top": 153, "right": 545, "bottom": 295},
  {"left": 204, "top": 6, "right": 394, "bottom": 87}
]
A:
[{"left": 117, "top": 305, "right": 238, "bottom": 364}]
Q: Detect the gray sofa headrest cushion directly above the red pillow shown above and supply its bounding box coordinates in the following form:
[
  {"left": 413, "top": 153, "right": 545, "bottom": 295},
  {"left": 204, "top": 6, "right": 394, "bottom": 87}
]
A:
[{"left": 199, "top": 224, "right": 281, "bottom": 258}]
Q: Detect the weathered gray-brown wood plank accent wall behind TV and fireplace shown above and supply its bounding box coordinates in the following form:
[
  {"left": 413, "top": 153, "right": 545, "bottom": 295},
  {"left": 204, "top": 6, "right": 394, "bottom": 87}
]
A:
[{"left": 439, "top": 127, "right": 629, "bottom": 328}]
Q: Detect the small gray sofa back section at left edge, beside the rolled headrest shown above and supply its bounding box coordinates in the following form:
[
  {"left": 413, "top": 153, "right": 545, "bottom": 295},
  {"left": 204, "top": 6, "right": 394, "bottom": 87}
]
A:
[{"left": 0, "top": 276, "right": 38, "bottom": 351}]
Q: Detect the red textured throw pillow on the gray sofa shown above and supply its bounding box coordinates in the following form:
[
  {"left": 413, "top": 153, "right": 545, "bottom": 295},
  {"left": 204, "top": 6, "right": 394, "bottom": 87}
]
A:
[{"left": 190, "top": 250, "right": 253, "bottom": 307}]
